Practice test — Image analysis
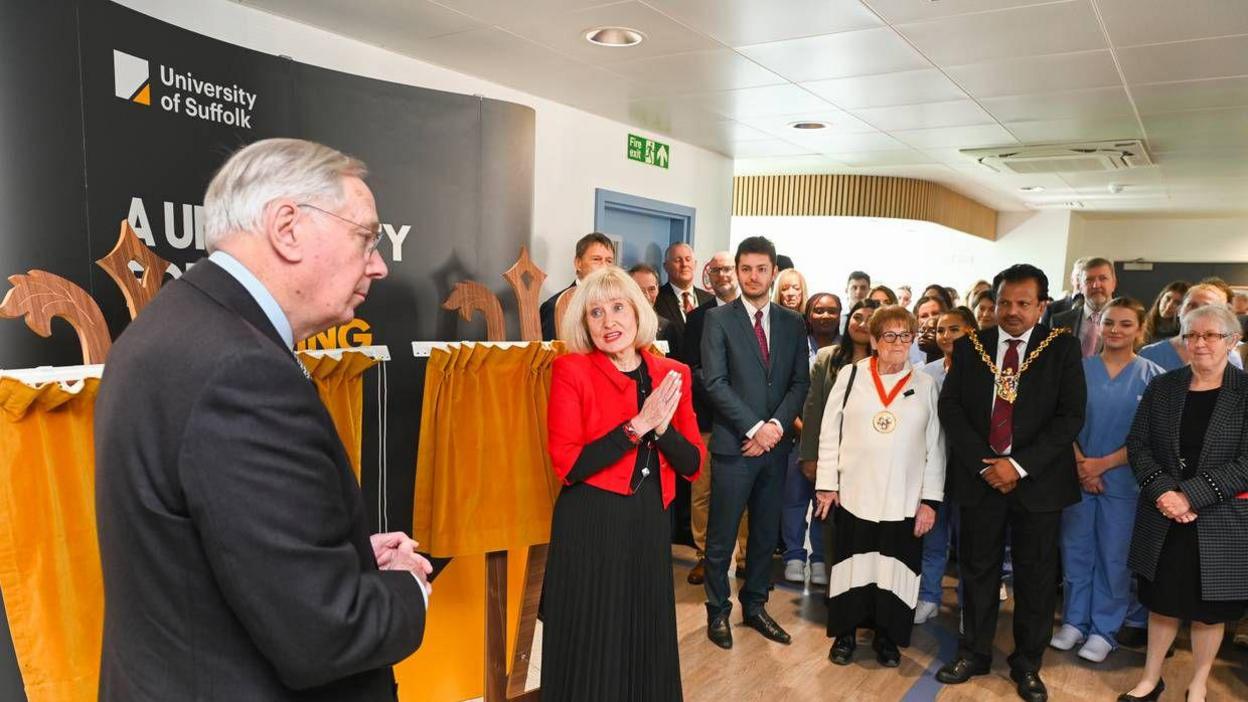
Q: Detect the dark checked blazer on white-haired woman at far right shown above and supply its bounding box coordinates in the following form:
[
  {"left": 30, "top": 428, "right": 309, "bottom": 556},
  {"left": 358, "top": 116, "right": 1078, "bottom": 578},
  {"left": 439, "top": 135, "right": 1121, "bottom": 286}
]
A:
[{"left": 1127, "top": 363, "right": 1248, "bottom": 600}]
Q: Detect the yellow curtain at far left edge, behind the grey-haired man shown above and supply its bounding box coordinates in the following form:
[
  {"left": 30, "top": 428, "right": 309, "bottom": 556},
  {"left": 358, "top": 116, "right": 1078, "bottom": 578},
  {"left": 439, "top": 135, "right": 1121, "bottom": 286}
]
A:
[{"left": 0, "top": 377, "right": 104, "bottom": 702}]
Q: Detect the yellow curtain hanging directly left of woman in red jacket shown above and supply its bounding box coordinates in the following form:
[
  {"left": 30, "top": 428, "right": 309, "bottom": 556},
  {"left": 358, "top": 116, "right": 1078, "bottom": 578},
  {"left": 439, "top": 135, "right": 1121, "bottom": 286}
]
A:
[{"left": 412, "top": 342, "right": 560, "bottom": 557}]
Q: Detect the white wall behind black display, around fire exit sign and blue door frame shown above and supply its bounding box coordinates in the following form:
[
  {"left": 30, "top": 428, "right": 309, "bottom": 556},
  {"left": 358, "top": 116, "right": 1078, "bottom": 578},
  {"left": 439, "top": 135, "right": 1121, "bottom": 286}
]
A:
[{"left": 119, "top": 0, "right": 733, "bottom": 292}]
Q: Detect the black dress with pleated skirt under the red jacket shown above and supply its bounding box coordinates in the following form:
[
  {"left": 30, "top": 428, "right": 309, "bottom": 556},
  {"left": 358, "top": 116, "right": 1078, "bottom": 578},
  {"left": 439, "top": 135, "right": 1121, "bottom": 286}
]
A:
[{"left": 542, "top": 363, "right": 699, "bottom": 702}]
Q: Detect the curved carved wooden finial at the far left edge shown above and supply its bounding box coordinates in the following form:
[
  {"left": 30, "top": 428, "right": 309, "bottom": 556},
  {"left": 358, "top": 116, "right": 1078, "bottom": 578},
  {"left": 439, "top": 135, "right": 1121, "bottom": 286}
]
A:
[{"left": 0, "top": 270, "right": 112, "bottom": 365}]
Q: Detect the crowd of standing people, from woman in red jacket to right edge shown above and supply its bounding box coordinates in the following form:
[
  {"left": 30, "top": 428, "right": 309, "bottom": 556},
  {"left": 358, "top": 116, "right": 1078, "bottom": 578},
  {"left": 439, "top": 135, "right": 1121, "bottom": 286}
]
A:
[{"left": 543, "top": 234, "right": 1248, "bottom": 702}]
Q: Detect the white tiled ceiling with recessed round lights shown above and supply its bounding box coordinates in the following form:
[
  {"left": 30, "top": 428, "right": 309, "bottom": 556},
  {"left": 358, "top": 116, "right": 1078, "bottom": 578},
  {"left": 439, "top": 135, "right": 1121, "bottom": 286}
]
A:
[{"left": 236, "top": 0, "right": 1248, "bottom": 214}]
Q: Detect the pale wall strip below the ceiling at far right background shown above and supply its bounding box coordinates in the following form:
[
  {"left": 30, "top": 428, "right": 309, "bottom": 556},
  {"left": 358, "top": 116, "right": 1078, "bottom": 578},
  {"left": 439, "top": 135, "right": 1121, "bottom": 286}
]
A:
[{"left": 1067, "top": 214, "right": 1248, "bottom": 270}]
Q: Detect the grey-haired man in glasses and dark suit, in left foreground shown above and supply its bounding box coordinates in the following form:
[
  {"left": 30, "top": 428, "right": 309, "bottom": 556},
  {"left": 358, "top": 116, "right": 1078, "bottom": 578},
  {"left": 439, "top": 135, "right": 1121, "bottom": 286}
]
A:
[{"left": 95, "top": 139, "right": 431, "bottom": 702}]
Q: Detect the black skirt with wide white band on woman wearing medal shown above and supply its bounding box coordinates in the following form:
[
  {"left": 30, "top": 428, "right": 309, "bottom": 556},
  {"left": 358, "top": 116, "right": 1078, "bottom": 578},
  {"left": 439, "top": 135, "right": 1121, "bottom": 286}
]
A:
[{"left": 827, "top": 507, "right": 924, "bottom": 646}]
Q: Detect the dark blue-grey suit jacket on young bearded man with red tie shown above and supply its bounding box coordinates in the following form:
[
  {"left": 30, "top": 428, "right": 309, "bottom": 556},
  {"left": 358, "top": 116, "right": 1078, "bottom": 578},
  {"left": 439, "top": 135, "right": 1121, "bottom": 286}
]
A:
[{"left": 701, "top": 297, "right": 810, "bottom": 455}]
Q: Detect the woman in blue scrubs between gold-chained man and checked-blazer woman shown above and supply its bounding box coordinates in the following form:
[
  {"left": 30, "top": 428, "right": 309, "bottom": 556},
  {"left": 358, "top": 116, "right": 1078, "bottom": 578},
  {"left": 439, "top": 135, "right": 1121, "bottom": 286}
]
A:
[{"left": 1050, "top": 297, "right": 1164, "bottom": 663}]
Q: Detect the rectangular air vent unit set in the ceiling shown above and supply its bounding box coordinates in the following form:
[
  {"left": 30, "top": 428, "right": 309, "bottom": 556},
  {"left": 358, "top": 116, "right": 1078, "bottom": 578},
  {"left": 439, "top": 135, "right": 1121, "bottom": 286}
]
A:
[{"left": 961, "top": 139, "right": 1153, "bottom": 175}]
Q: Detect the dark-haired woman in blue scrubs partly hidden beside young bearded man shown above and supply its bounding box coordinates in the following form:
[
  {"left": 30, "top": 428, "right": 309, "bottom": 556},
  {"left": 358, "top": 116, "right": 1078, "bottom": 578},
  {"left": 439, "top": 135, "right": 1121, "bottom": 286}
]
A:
[{"left": 780, "top": 287, "right": 841, "bottom": 585}]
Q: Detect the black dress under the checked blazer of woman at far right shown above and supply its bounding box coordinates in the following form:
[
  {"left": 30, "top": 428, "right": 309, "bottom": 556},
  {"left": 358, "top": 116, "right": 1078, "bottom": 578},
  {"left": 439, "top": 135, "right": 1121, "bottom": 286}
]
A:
[{"left": 1139, "top": 388, "right": 1244, "bottom": 625}]
